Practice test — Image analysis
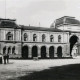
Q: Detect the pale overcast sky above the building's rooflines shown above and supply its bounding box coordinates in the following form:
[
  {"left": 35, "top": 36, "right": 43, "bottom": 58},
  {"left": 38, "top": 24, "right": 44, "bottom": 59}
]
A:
[{"left": 0, "top": 0, "right": 80, "bottom": 27}]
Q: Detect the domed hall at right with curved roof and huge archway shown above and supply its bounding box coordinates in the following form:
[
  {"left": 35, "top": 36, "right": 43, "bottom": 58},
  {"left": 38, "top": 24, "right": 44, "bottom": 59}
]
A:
[{"left": 51, "top": 16, "right": 80, "bottom": 56}]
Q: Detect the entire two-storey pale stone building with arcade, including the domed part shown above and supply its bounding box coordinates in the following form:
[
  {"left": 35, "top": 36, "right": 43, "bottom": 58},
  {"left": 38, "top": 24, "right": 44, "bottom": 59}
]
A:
[{"left": 0, "top": 16, "right": 80, "bottom": 59}]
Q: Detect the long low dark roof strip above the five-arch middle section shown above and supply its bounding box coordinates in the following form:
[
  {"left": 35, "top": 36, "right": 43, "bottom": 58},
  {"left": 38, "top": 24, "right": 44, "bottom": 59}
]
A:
[{"left": 21, "top": 25, "right": 62, "bottom": 32}]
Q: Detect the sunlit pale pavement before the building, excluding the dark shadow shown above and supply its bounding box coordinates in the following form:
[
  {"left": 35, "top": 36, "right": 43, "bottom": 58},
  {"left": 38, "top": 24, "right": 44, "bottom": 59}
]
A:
[{"left": 0, "top": 58, "right": 80, "bottom": 80}]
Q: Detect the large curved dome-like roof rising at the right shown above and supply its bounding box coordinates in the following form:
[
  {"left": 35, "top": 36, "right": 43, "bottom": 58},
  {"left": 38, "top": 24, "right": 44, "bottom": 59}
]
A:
[{"left": 51, "top": 16, "right": 80, "bottom": 27}]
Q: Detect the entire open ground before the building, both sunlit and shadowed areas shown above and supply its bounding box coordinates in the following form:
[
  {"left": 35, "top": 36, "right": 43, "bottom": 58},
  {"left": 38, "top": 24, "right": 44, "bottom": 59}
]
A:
[{"left": 0, "top": 58, "right": 80, "bottom": 80}]
